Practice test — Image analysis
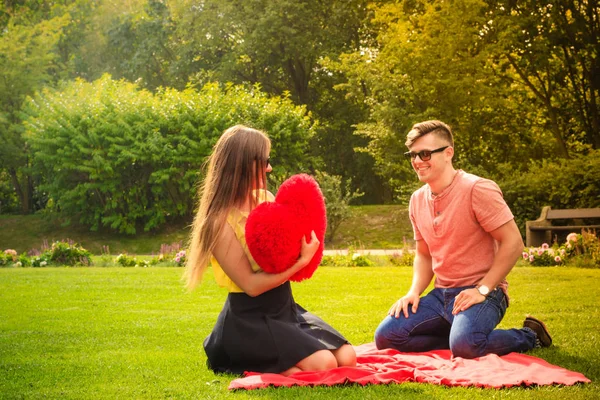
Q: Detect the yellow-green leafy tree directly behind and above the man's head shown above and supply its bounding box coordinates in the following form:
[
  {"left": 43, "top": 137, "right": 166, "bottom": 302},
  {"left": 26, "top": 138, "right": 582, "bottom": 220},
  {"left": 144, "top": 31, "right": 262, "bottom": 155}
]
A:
[{"left": 330, "top": 0, "right": 514, "bottom": 202}]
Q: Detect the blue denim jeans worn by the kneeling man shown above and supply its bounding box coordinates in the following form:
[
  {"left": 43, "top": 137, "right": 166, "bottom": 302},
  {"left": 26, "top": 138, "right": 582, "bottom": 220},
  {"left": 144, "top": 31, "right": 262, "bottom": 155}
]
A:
[{"left": 375, "top": 286, "right": 536, "bottom": 358}]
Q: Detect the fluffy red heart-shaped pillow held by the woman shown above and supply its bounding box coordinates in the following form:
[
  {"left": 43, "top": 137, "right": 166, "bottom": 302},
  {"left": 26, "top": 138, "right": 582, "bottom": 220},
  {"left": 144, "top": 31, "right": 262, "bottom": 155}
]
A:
[{"left": 245, "top": 174, "right": 327, "bottom": 282}]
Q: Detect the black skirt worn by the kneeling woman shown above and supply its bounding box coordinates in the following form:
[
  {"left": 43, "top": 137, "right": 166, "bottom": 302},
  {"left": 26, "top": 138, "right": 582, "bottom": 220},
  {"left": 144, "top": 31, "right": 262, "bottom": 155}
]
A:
[{"left": 204, "top": 282, "right": 348, "bottom": 374}]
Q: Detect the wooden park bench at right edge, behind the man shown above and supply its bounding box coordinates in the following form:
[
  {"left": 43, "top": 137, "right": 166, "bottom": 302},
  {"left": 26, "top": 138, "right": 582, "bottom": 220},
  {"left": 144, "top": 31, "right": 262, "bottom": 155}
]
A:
[{"left": 525, "top": 206, "right": 600, "bottom": 246}]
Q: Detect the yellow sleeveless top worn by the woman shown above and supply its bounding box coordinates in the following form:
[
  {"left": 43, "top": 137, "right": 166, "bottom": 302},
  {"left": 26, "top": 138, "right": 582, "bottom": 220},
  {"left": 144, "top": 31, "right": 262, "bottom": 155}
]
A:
[{"left": 211, "top": 189, "right": 275, "bottom": 293}]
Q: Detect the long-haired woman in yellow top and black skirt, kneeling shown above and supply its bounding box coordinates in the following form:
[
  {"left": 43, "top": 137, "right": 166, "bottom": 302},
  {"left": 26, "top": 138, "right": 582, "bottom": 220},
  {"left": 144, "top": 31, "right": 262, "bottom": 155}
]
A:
[{"left": 186, "top": 125, "right": 356, "bottom": 375}]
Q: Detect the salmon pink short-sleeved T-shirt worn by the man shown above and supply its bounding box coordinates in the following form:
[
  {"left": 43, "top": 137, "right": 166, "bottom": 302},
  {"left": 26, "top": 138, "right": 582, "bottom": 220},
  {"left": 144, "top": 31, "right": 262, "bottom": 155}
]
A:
[{"left": 409, "top": 170, "right": 514, "bottom": 292}]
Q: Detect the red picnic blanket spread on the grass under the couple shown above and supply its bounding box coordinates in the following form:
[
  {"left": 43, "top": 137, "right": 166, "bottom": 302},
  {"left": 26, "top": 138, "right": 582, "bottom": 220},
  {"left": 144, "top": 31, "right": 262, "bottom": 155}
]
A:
[{"left": 229, "top": 343, "right": 590, "bottom": 390}]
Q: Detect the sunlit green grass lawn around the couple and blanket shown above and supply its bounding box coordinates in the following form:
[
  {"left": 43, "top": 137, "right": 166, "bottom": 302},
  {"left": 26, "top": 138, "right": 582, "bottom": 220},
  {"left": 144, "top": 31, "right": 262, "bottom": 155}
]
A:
[{"left": 0, "top": 267, "right": 600, "bottom": 400}]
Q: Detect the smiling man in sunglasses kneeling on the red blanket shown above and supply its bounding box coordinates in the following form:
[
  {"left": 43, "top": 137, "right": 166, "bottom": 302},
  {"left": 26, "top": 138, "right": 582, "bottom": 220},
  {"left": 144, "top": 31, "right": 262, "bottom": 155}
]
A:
[{"left": 375, "top": 121, "right": 552, "bottom": 358}]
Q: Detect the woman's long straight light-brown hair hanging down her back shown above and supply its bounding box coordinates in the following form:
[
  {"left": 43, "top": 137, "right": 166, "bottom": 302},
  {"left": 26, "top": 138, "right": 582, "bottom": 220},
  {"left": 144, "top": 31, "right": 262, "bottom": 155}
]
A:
[{"left": 185, "top": 125, "right": 271, "bottom": 289}]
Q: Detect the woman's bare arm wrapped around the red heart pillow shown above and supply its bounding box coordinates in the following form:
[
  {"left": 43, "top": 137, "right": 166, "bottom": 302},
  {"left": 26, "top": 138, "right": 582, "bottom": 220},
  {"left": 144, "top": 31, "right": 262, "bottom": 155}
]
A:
[{"left": 213, "top": 224, "right": 319, "bottom": 297}]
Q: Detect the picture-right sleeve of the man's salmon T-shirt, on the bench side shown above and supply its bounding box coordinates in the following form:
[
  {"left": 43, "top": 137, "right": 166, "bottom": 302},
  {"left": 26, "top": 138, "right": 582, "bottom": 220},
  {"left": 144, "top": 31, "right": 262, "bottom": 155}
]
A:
[{"left": 471, "top": 179, "right": 514, "bottom": 232}]
